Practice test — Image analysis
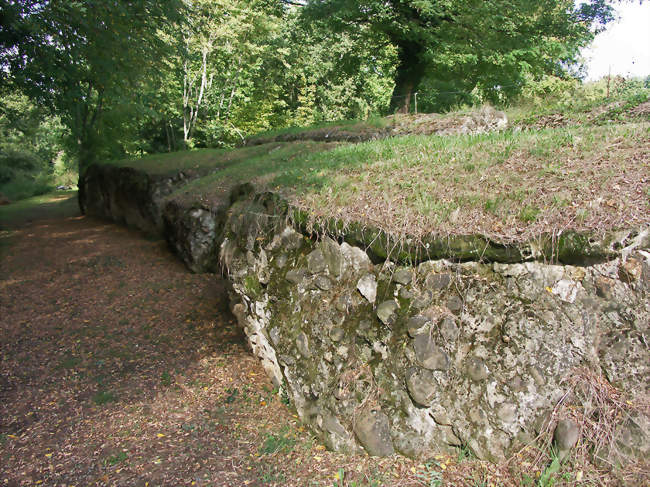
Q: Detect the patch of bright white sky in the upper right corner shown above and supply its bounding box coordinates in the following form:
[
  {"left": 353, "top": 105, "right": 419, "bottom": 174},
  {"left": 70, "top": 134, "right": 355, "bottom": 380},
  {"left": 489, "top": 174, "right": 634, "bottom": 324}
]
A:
[{"left": 583, "top": 0, "right": 650, "bottom": 80}]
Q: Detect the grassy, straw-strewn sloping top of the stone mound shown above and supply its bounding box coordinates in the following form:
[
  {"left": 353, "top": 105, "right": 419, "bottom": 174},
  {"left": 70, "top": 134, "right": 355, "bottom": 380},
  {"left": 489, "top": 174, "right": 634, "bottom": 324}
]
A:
[{"left": 97, "top": 94, "right": 650, "bottom": 250}]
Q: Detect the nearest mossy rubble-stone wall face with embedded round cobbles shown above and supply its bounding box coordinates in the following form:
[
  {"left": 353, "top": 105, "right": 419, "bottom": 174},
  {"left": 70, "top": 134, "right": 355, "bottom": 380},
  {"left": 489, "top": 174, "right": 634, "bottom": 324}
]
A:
[{"left": 221, "top": 193, "right": 650, "bottom": 460}]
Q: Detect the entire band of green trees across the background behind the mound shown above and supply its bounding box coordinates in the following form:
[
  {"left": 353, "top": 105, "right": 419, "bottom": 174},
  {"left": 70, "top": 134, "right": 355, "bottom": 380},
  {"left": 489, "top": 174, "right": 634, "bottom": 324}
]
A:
[{"left": 0, "top": 0, "right": 628, "bottom": 181}]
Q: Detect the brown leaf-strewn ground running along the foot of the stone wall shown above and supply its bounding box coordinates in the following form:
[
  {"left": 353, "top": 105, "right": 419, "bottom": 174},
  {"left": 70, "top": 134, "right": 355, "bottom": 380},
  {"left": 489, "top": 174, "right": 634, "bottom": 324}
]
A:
[{"left": 0, "top": 195, "right": 636, "bottom": 487}]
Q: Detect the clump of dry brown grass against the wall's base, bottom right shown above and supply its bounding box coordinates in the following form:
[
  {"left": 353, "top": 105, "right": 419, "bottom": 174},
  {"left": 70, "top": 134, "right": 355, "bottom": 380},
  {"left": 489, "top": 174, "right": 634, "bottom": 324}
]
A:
[{"left": 505, "top": 369, "right": 650, "bottom": 487}]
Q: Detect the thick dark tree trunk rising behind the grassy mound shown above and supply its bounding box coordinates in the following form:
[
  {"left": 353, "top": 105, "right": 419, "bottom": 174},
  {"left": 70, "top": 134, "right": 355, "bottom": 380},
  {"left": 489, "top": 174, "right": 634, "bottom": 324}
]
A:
[{"left": 390, "top": 41, "right": 424, "bottom": 113}]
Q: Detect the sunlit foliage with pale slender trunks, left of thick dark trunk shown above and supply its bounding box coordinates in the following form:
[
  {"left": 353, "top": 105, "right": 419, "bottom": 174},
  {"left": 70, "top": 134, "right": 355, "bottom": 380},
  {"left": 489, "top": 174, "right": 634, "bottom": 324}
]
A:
[{"left": 159, "top": 0, "right": 394, "bottom": 148}]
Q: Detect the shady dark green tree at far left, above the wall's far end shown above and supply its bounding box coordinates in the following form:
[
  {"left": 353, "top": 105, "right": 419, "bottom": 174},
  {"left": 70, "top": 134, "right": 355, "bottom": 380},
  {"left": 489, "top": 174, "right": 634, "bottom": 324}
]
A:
[{"left": 0, "top": 0, "right": 182, "bottom": 169}]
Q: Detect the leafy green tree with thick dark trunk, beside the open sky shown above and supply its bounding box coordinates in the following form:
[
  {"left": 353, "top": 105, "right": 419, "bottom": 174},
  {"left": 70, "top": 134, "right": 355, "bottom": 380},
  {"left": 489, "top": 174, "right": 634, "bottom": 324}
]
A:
[{"left": 304, "top": 0, "right": 612, "bottom": 112}]
